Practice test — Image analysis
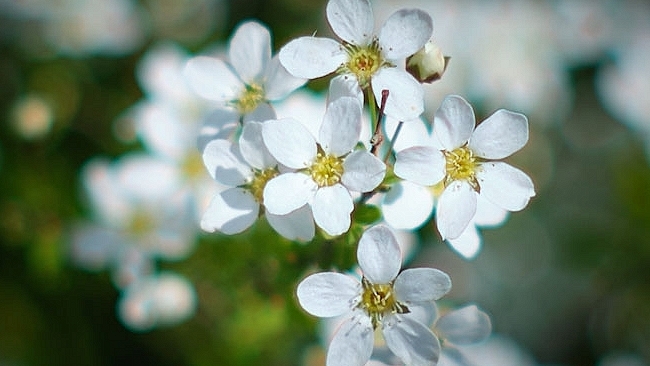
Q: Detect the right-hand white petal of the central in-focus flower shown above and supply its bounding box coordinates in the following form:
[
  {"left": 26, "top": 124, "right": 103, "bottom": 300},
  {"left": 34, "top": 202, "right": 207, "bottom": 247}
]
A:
[{"left": 341, "top": 150, "right": 386, "bottom": 192}]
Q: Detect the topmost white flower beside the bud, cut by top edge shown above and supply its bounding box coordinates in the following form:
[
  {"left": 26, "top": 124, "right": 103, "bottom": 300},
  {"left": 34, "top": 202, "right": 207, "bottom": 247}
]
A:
[{"left": 280, "top": 0, "right": 433, "bottom": 121}]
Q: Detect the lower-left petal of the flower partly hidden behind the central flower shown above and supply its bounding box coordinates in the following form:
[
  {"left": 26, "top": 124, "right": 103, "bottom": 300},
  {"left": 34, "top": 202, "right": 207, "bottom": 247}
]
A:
[{"left": 201, "top": 188, "right": 260, "bottom": 235}]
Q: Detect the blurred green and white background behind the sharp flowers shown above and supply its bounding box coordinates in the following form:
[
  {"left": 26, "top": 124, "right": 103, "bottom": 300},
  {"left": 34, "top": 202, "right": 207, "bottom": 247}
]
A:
[{"left": 0, "top": 0, "right": 650, "bottom": 366}]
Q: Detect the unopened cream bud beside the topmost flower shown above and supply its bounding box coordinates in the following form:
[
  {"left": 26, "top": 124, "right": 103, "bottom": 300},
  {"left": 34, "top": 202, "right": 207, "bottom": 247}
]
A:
[{"left": 406, "top": 41, "right": 450, "bottom": 84}]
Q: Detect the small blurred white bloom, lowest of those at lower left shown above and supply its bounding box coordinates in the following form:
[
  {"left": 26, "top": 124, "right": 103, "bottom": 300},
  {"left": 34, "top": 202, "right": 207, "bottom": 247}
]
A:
[{"left": 117, "top": 272, "right": 197, "bottom": 332}]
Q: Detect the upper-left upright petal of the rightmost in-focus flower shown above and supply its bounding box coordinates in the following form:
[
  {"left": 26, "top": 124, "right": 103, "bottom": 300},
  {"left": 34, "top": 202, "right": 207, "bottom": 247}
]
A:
[{"left": 433, "top": 95, "right": 476, "bottom": 151}]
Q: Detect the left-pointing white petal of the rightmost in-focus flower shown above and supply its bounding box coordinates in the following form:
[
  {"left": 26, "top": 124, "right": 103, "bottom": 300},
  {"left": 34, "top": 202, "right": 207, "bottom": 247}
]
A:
[{"left": 395, "top": 146, "right": 445, "bottom": 186}]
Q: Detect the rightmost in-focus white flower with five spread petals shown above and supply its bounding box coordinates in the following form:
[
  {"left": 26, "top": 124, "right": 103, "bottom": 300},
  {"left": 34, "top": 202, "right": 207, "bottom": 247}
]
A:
[{"left": 395, "top": 95, "right": 535, "bottom": 239}]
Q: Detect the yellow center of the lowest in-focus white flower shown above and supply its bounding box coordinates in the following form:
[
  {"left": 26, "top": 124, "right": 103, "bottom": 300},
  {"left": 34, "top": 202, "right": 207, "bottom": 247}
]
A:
[{"left": 359, "top": 277, "right": 409, "bottom": 328}]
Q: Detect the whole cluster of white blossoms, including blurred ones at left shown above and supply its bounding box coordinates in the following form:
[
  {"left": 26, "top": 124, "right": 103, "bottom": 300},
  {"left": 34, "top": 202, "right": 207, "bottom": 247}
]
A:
[{"left": 74, "top": 0, "right": 535, "bottom": 366}]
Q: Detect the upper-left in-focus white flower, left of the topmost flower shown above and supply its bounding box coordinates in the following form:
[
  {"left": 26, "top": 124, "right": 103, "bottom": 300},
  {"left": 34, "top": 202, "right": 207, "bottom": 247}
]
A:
[{"left": 185, "top": 21, "right": 305, "bottom": 121}]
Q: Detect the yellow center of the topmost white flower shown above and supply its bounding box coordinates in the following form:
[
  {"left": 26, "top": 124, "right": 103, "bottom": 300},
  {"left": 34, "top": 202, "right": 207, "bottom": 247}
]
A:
[{"left": 338, "top": 40, "right": 384, "bottom": 89}]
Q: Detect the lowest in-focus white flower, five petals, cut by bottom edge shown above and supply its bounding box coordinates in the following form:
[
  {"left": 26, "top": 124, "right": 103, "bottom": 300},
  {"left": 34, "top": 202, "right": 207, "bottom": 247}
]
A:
[{"left": 297, "top": 225, "right": 451, "bottom": 366}]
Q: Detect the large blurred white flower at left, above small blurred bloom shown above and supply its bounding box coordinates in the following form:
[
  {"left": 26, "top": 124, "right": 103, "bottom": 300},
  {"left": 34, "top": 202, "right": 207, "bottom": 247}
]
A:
[{"left": 71, "top": 154, "right": 196, "bottom": 288}]
